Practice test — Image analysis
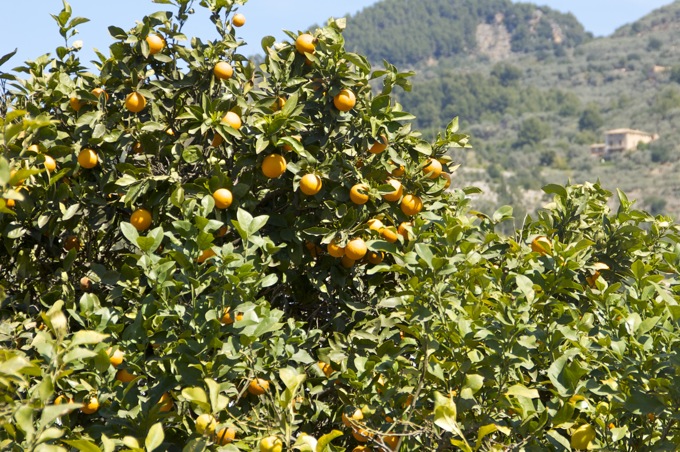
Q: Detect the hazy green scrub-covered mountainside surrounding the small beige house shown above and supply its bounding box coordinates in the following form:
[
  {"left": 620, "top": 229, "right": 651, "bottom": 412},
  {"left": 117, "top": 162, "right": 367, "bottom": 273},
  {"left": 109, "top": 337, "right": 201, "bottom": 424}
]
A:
[{"left": 345, "top": 0, "right": 680, "bottom": 217}]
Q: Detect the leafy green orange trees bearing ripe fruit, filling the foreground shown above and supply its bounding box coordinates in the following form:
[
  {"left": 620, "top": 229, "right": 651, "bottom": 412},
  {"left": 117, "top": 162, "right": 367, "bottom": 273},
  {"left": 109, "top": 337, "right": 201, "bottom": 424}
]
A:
[{"left": 0, "top": 0, "right": 680, "bottom": 451}]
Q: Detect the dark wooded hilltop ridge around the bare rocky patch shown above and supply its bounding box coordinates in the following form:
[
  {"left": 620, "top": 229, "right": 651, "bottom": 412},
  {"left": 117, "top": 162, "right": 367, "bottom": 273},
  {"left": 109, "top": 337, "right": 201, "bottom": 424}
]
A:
[{"left": 346, "top": 0, "right": 590, "bottom": 65}]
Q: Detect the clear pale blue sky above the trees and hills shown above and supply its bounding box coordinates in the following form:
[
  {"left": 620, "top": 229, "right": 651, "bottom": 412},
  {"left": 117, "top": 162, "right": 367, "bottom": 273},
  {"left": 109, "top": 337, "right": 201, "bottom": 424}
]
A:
[{"left": 0, "top": 0, "right": 672, "bottom": 68}]
